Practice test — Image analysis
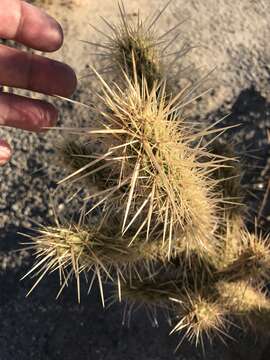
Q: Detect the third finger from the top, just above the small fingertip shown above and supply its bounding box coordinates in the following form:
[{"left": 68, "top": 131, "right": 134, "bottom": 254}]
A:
[{"left": 0, "top": 94, "right": 58, "bottom": 132}]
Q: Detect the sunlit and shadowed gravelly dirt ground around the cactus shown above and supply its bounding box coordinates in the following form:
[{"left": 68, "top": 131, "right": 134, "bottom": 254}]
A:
[{"left": 0, "top": 0, "right": 270, "bottom": 360}]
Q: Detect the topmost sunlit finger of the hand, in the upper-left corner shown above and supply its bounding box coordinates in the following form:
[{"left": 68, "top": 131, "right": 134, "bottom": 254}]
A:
[{"left": 0, "top": 0, "right": 63, "bottom": 51}]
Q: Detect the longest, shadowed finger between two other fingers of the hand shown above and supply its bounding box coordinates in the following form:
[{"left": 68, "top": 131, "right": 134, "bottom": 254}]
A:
[{"left": 0, "top": 45, "right": 77, "bottom": 97}]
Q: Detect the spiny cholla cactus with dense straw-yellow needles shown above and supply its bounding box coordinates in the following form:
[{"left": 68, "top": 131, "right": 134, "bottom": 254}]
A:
[{"left": 24, "top": 1, "right": 270, "bottom": 352}]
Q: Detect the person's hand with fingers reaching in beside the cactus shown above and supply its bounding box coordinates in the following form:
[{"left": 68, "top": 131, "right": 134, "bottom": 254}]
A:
[{"left": 0, "top": 0, "right": 77, "bottom": 165}]
